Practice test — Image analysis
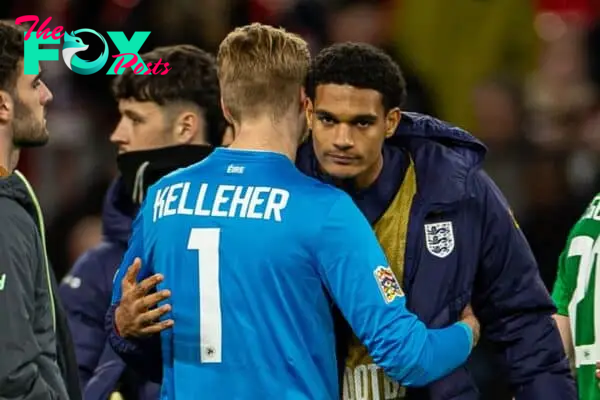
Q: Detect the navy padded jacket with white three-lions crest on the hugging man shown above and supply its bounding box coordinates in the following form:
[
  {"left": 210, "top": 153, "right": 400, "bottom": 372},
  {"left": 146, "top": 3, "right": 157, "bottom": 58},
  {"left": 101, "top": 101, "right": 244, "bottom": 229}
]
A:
[{"left": 107, "top": 113, "right": 577, "bottom": 400}]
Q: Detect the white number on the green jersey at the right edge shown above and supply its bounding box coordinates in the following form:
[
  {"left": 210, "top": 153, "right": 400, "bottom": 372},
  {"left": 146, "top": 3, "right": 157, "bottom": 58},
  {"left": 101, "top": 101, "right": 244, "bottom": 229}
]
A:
[{"left": 567, "top": 236, "right": 600, "bottom": 368}]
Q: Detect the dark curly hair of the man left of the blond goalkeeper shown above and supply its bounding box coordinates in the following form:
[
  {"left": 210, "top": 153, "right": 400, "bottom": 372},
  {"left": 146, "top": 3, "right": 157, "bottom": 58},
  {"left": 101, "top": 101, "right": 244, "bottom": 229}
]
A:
[{"left": 112, "top": 45, "right": 227, "bottom": 146}]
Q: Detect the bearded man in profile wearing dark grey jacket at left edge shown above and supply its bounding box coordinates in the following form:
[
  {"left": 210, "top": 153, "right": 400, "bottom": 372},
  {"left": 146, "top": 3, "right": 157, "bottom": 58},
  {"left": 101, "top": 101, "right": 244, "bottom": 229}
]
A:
[{"left": 0, "top": 21, "right": 81, "bottom": 400}]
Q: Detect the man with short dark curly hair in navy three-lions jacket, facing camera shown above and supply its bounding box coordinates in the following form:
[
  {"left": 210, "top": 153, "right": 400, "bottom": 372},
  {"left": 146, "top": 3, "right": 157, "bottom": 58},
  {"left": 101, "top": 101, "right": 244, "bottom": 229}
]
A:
[{"left": 297, "top": 44, "right": 576, "bottom": 400}]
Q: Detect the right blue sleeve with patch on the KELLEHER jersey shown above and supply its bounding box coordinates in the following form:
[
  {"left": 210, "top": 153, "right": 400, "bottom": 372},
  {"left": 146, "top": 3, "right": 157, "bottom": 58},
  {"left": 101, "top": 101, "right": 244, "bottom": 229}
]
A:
[{"left": 314, "top": 194, "right": 472, "bottom": 386}]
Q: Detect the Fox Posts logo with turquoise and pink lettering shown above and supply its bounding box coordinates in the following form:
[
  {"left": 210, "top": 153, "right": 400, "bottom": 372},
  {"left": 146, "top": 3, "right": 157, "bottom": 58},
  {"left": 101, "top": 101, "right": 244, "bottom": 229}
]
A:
[{"left": 15, "top": 15, "right": 171, "bottom": 75}]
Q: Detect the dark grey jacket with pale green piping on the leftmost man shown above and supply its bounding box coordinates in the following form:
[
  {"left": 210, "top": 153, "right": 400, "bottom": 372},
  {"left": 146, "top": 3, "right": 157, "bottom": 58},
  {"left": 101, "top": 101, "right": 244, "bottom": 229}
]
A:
[{"left": 0, "top": 172, "right": 81, "bottom": 400}]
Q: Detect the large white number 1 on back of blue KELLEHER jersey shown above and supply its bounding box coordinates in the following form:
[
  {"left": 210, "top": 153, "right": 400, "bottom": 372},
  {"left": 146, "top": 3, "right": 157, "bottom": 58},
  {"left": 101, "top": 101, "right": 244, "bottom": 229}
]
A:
[{"left": 188, "top": 228, "right": 222, "bottom": 363}]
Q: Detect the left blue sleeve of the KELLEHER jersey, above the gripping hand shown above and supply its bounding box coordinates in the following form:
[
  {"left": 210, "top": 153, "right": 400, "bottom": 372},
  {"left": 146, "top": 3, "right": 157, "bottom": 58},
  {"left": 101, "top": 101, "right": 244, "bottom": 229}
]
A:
[{"left": 112, "top": 200, "right": 152, "bottom": 304}]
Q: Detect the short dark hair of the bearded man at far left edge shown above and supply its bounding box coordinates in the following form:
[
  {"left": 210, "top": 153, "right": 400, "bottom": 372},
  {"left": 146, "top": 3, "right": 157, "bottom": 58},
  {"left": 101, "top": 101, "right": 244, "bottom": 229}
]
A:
[{"left": 0, "top": 20, "right": 26, "bottom": 92}]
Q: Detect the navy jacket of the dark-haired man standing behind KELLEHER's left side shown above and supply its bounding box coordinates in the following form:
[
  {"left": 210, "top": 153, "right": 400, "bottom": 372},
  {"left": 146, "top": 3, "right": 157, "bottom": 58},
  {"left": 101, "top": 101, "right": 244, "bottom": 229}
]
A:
[{"left": 59, "top": 180, "right": 160, "bottom": 400}]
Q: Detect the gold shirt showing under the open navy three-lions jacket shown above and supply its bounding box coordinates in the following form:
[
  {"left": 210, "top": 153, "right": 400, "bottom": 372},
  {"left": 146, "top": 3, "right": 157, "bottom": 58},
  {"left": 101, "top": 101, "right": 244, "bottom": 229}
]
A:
[{"left": 343, "top": 156, "right": 417, "bottom": 400}]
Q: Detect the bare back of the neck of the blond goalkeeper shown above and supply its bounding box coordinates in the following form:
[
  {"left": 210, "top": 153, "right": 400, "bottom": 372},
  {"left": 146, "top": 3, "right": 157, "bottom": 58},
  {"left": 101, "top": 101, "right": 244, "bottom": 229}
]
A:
[{"left": 229, "top": 117, "right": 301, "bottom": 162}]
